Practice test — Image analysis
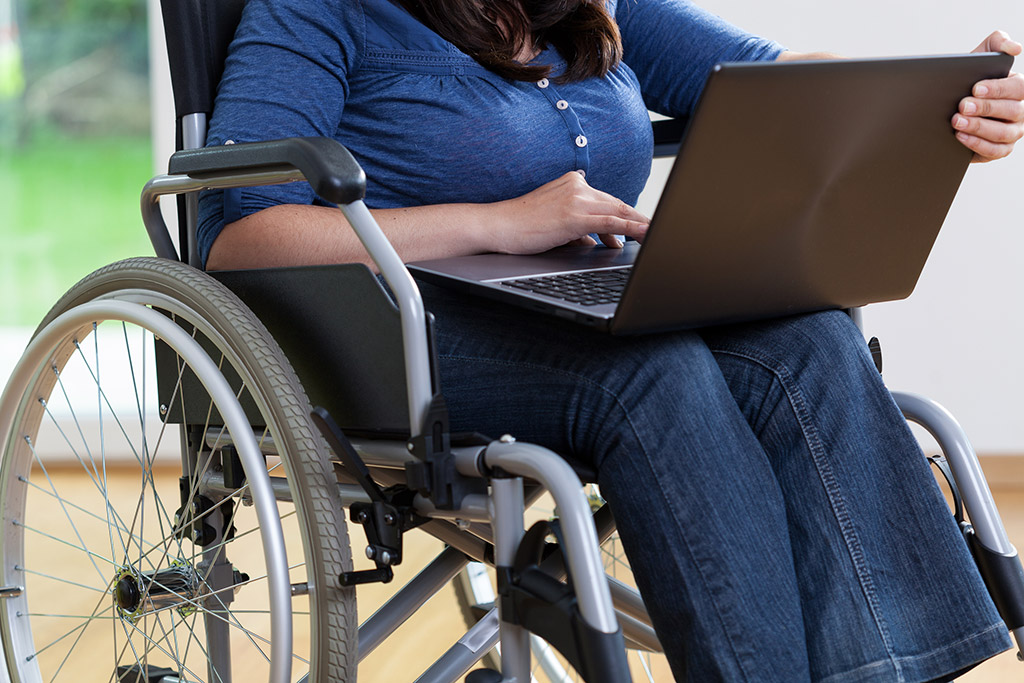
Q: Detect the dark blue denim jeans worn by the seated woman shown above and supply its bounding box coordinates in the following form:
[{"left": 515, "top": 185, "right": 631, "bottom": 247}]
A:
[{"left": 423, "top": 286, "right": 1010, "bottom": 683}]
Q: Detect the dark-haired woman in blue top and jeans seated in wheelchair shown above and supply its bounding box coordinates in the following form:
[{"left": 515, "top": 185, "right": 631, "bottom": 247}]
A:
[{"left": 200, "top": 0, "right": 1024, "bottom": 683}]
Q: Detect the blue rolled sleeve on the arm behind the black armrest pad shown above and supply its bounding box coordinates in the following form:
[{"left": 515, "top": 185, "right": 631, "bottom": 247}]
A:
[{"left": 197, "top": 0, "right": 364, "bottom": 262}]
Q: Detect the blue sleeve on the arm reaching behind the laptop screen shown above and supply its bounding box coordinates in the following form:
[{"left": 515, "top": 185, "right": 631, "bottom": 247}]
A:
[{"left": 615, "top": 0, "right": 782, "bottom": 117}]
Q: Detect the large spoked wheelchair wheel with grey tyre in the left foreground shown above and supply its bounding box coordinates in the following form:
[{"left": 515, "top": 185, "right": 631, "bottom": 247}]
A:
[{"left": 0, "top": 259, "right": 356, "bottom": 683}]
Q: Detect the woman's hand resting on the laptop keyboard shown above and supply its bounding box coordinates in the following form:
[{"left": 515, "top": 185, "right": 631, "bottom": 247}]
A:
[{"left": 488, "top": 171, "right": 650, "bottom": 254}]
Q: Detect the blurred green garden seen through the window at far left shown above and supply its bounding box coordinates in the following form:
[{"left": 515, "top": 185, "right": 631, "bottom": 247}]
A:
[{"left": 0, "top": 0, "right": 153, "bottom": 329}]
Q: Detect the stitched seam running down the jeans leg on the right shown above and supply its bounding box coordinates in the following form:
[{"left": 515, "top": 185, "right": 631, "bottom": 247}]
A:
[{"left": 712, "top": 348, "right": 904, "bottom": 683}]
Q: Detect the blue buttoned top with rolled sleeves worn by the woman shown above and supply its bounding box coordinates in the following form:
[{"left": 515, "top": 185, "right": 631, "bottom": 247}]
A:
[{"left": 199, "top": 0, "right": 781, "bottom": 262}]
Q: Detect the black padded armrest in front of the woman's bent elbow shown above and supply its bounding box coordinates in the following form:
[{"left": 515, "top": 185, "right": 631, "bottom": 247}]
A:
[{"left": 167, "top": 137, "right": 367, "bottom": 204}]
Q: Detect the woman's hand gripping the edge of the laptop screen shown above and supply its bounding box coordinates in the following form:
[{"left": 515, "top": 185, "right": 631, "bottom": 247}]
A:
[{"left": 952, "top": 31, "right": 1024, "bottom": 162}]
